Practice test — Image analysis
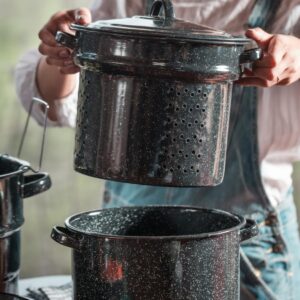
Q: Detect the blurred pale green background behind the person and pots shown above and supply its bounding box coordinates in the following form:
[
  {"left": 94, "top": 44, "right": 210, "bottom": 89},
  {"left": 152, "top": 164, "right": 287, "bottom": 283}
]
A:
[{"left": 0, "top": 0, "right": 300, "bottom": 277}]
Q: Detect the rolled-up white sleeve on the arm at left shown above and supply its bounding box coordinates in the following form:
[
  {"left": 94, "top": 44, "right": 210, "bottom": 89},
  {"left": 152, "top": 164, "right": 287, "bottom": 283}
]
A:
[{"left": 14, "top": 49, "right": 79, "bottom": 127}]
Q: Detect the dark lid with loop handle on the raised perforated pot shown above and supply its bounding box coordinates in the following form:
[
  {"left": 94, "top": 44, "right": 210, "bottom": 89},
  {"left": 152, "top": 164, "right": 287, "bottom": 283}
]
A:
[{"left": 71, "top": 0, "right": 249, "bottom": 44}]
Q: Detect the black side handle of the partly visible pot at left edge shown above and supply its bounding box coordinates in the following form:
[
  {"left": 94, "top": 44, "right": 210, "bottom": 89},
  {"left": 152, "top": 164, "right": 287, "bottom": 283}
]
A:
[{"left": 22, "top": 173, "right": 51, "bottom": 198}]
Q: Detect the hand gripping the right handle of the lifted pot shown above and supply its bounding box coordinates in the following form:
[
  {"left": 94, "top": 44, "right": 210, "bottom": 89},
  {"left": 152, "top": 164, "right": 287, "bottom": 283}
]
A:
[{"left": 237, "top": 28, "right": 300, "bottom": 87}]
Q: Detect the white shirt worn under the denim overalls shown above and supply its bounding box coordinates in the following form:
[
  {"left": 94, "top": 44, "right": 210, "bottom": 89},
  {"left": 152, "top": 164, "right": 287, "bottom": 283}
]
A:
[{"left": 15, "top": 0, "right": 300, "bottom": 206}]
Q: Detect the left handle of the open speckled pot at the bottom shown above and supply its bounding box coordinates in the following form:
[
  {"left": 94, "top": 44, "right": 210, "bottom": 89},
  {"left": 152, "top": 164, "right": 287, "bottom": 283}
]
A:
[{"left": 51, "top": 226, "right": 83, "bottom": 251}]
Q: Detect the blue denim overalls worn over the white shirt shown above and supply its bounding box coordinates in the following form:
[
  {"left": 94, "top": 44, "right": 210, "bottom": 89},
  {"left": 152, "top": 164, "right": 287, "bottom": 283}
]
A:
[{"left": 103, "top": 0, "right": 300, "bottom": 300}]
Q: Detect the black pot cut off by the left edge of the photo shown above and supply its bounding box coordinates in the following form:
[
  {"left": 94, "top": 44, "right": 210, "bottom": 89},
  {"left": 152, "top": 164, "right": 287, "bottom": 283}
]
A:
[{"left": 0, "top": 155, "right": 51, "bottom": 293}]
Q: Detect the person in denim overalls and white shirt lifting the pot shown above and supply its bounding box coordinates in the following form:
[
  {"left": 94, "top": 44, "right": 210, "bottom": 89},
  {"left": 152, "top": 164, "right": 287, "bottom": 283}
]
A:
[{"left": 15, "top": 0, "right": 300, "bottom": 300}]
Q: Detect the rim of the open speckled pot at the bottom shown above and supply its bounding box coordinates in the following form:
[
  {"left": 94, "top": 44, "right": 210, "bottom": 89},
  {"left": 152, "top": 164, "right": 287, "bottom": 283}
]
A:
[{"left": 65, "top": 205, "right": 252, "bottom": 241}]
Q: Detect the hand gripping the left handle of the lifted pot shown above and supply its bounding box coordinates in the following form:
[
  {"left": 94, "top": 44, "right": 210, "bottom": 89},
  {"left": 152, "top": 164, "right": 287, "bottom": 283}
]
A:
[{"left": 39, "top": 8, "right": 91, "bottom": 74}]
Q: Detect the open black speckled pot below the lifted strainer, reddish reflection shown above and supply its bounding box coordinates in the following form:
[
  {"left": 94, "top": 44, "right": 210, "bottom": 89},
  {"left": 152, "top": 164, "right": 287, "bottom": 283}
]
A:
[{"left": 51, "top": 206, "right": 257, "bottom": 300}]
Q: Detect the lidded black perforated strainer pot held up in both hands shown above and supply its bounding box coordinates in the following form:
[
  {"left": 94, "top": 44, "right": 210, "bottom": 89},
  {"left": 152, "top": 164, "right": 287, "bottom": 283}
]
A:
[{"left": 57, "top": 0, "right": 261, "bottom": 186}]
